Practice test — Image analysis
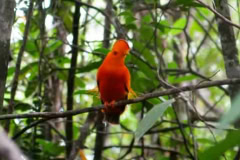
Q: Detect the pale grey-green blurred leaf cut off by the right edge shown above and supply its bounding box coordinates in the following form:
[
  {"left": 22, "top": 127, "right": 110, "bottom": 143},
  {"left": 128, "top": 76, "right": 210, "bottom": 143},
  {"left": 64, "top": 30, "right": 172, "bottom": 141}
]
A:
[{"left": 219, "top": 93, "right": 240, "bottom": 128}]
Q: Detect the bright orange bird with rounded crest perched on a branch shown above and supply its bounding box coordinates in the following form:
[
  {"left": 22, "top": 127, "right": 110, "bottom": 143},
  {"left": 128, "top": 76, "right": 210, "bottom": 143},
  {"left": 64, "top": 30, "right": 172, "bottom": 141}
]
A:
[{"left": 97, "top": 39, "right": 132, "bottom": 124}]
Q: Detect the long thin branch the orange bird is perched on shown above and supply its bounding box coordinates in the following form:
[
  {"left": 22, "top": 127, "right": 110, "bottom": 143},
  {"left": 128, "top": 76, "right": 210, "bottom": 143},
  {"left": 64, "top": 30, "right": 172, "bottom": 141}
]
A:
[{"left": 0, "top": 78, "right": 240, "bottom": 120}]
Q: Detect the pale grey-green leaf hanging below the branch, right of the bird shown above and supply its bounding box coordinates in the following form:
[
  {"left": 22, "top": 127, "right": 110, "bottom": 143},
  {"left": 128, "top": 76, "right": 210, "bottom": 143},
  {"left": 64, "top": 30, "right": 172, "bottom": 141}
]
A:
[{"left": 135, "top": 99, "right": 175, "bottom": 140}]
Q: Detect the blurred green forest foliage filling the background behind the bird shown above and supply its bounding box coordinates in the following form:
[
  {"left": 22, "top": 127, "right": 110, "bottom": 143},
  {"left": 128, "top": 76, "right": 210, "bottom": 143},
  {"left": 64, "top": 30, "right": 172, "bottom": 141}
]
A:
[{"left": 1, "top": 0, "right": 240, "bottom": 160}]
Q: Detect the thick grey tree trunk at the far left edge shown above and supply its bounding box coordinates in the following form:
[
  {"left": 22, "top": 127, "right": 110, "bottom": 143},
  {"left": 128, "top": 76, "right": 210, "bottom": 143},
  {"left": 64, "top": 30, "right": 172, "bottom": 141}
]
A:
[{"left": 0, "top": 0, "right": 15, "bottom": 111}]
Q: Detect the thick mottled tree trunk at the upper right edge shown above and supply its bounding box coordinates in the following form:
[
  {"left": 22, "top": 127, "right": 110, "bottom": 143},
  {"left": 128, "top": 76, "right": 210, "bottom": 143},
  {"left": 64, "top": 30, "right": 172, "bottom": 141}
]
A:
[{"left": 215, "top": 0, "right": 240, "bottom": 127}]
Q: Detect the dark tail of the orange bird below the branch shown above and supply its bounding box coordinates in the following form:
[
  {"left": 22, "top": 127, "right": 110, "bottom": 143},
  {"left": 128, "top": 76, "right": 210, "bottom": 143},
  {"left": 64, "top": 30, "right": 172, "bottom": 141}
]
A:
[{"left": 105, "top": 106, "right": 126, "bottom": 124}]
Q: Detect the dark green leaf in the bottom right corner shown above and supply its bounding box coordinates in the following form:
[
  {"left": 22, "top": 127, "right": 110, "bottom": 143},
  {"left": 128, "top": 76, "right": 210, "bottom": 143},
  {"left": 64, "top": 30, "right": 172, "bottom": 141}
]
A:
[{"left": 200, "top": 130, "right": 240, "bottom": 160}]
